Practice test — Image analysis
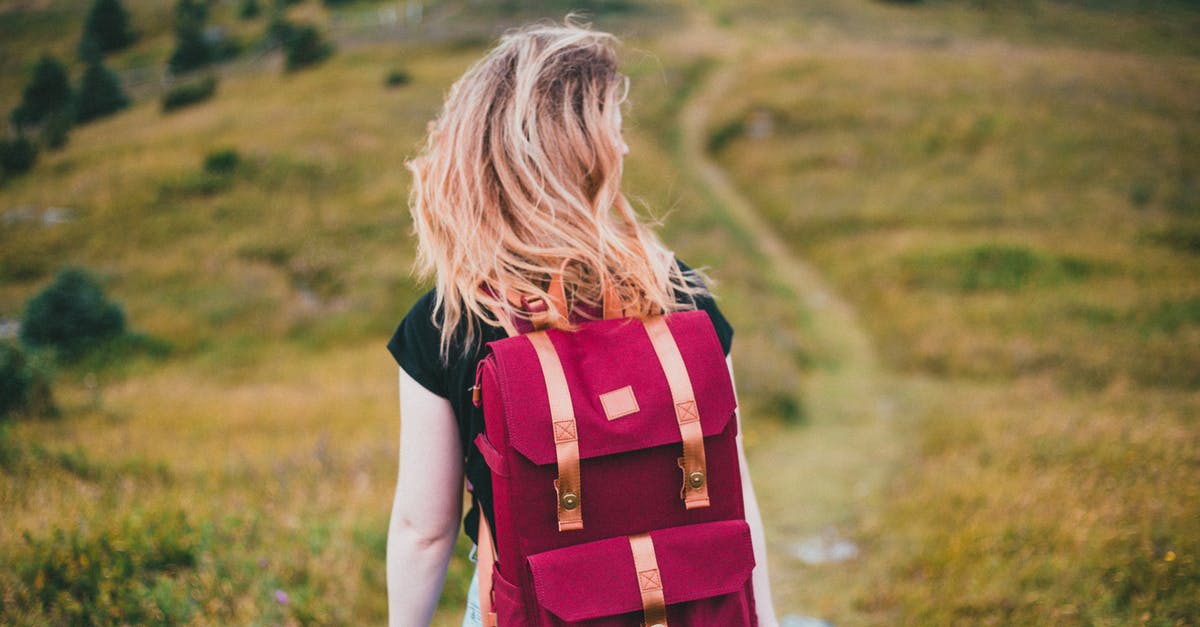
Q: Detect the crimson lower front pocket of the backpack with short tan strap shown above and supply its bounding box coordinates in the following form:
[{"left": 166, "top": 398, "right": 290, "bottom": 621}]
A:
[{"left": 528, "top": 520, "right": 755, "bottom": 627}]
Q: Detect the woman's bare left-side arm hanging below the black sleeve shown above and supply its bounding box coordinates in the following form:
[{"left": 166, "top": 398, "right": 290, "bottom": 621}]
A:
[{"left": 388, "top": 369, "right": 463, "bottom": 627}]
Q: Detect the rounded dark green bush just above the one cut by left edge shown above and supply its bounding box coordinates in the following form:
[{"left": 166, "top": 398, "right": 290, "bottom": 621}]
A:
[{"left": 20, "top": 268, "right": 125, "bottom": 360}]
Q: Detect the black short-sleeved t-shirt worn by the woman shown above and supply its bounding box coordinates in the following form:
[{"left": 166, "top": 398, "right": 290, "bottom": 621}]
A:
[{"left": 388, "top": 262, "right": 733, "bottom": 541}]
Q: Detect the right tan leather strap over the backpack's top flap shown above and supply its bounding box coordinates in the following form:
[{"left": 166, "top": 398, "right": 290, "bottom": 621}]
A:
[{"left": 642, "top": 316, "right": 708, "bottom": 509}]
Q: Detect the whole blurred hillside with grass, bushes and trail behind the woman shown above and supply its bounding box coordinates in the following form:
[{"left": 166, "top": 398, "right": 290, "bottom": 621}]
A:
[{"left": 0, "top": 0, "right": 1200, "bottom": 626}]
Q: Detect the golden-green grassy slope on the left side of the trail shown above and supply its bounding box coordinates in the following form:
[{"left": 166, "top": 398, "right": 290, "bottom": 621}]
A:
[{"left": 0, "top": 2, "right": 798, "bottom": 625}]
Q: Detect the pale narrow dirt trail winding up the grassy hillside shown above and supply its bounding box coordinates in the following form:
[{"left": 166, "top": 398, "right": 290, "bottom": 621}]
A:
[{"left": 680, "top": 21, "right": 900, "bottom": 623}]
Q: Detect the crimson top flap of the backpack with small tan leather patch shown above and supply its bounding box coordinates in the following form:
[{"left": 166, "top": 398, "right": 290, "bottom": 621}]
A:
[{"left": 488, "top": 310, "right": 737, "bottom": 465}]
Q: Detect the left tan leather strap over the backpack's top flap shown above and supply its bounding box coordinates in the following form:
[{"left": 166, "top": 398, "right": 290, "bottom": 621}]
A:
[{"left": 526, "top": 332, "right": 583, "bottom": 531}]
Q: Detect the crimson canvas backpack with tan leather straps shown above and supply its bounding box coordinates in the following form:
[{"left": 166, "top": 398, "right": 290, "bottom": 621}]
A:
[{"left": 475, "top": 280, "right": 757, "bottom": 627}]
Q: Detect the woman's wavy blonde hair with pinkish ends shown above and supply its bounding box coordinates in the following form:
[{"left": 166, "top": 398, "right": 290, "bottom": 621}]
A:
[{"left": 407, "top": 16, "right": 707, "bottom": 359}]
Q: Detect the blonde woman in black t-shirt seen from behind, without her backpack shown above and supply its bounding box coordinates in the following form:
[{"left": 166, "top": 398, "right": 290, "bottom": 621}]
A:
[{"left": 388, "top": 20, "right": 776, "bottom": 627}]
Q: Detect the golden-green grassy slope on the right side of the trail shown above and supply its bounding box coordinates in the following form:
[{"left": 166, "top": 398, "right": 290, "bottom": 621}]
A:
[{"left": 709, "top": 2, "right": 1200, "bottom": 625}]
